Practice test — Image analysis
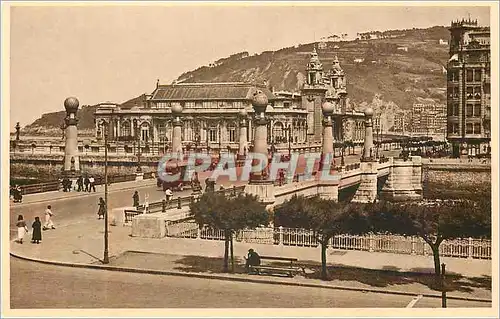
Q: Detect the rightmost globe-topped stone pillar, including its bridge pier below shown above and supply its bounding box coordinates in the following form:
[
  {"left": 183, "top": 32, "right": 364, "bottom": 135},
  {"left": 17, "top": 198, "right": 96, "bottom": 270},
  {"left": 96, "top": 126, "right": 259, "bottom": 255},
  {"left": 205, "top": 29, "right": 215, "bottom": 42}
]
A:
[{"left": 353, "top": 108, "right": 379, "bottom": 203}]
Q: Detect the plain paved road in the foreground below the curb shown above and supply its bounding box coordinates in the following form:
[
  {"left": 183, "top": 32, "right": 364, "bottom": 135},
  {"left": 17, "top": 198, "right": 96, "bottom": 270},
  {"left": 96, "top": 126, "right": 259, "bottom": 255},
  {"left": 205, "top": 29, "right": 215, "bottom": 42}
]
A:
[{"left": 10, "top": 257, "right": 491, "bottom": 309}]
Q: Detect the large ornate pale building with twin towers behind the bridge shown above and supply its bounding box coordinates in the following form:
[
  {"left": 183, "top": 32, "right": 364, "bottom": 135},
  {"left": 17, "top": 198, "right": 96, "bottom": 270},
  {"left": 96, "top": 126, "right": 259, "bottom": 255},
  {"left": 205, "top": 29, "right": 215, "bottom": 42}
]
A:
[{"left": 95, "top": 49, "right": 364, "bottom": 154}]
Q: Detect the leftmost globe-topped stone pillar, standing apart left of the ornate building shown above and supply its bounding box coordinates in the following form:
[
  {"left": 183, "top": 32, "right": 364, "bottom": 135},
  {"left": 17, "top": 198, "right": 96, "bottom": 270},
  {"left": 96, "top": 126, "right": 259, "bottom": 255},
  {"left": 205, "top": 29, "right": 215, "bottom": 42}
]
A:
[{"left": 63, "top": 97, "right": 80, "bottom": 177}]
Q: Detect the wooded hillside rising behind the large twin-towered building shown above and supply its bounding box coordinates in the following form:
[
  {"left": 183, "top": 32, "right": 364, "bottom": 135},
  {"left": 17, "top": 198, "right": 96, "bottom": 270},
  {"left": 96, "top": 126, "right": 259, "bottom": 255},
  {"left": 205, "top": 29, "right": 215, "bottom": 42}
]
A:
[{"left": 23, "top": 27, "right": 449, "bottom": 134}]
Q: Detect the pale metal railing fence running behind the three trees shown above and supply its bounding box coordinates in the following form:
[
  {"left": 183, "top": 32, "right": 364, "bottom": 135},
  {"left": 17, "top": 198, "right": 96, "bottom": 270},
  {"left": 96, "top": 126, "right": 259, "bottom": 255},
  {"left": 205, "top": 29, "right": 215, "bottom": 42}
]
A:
[{"left": 162, "top": 221, "right": 491, "bottom": 259}]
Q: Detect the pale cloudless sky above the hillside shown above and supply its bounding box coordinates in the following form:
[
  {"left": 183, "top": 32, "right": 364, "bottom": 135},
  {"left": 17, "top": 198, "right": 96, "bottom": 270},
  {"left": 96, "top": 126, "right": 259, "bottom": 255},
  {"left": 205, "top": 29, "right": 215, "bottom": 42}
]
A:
[{"left": 5, "top": 3, "right": 490, "bottom": 129}]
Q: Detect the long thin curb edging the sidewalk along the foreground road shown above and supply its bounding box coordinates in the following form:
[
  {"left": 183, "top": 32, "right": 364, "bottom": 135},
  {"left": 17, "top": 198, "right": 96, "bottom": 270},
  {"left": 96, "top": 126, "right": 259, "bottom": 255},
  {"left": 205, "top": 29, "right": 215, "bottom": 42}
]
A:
[{"left": 10, "top": 252, "right": 493, "bottom": 303}]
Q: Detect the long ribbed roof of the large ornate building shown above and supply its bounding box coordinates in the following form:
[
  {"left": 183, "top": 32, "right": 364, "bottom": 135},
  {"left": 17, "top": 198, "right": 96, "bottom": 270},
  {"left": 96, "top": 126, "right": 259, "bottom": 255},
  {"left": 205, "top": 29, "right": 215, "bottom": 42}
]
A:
[{"left": 151, "top": 82, "right": 275, "bottom": 101}]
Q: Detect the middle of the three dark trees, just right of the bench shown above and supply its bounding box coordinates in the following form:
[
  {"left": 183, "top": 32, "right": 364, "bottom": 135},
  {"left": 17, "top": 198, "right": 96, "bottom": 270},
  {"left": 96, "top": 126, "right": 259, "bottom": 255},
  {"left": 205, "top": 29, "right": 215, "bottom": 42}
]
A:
[{"left": 275, "top": 195, "right": 369, "bottom": 280}]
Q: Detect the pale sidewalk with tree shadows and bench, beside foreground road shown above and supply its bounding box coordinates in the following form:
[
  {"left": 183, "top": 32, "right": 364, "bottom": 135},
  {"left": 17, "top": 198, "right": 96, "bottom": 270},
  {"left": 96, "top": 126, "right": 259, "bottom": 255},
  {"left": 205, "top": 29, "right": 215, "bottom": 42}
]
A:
[{"left": 10, "top": 219, "right": 492, "bottom": 300}]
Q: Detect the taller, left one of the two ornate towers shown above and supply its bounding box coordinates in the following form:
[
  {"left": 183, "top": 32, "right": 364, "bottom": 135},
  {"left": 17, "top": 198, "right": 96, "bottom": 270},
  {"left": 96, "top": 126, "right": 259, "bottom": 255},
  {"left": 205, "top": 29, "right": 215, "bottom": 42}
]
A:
[{"left": 301, "top": 48, "right": 327, "bottom": 143}]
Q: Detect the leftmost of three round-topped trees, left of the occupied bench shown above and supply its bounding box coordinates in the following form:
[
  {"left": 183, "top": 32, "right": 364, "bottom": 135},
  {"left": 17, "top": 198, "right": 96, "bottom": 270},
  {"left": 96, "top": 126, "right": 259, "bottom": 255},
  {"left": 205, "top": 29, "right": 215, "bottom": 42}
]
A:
[{"left": 189, "top": 193, "right": 271, "bottom": 272}]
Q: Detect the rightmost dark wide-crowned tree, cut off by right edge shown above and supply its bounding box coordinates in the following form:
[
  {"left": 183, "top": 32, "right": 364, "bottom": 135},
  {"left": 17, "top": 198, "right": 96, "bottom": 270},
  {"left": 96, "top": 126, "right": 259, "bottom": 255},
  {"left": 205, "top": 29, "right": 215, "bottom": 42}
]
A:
[{"left": 370, "top": 200, "right": 491, "bottom": 276}]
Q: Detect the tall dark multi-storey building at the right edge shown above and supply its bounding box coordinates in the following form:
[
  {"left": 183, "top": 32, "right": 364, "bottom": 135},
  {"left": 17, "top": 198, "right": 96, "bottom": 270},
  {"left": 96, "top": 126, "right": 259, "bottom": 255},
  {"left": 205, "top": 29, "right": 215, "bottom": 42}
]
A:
[{"left": 447, "top": 19, "right": 491, "bottom": 157}]
